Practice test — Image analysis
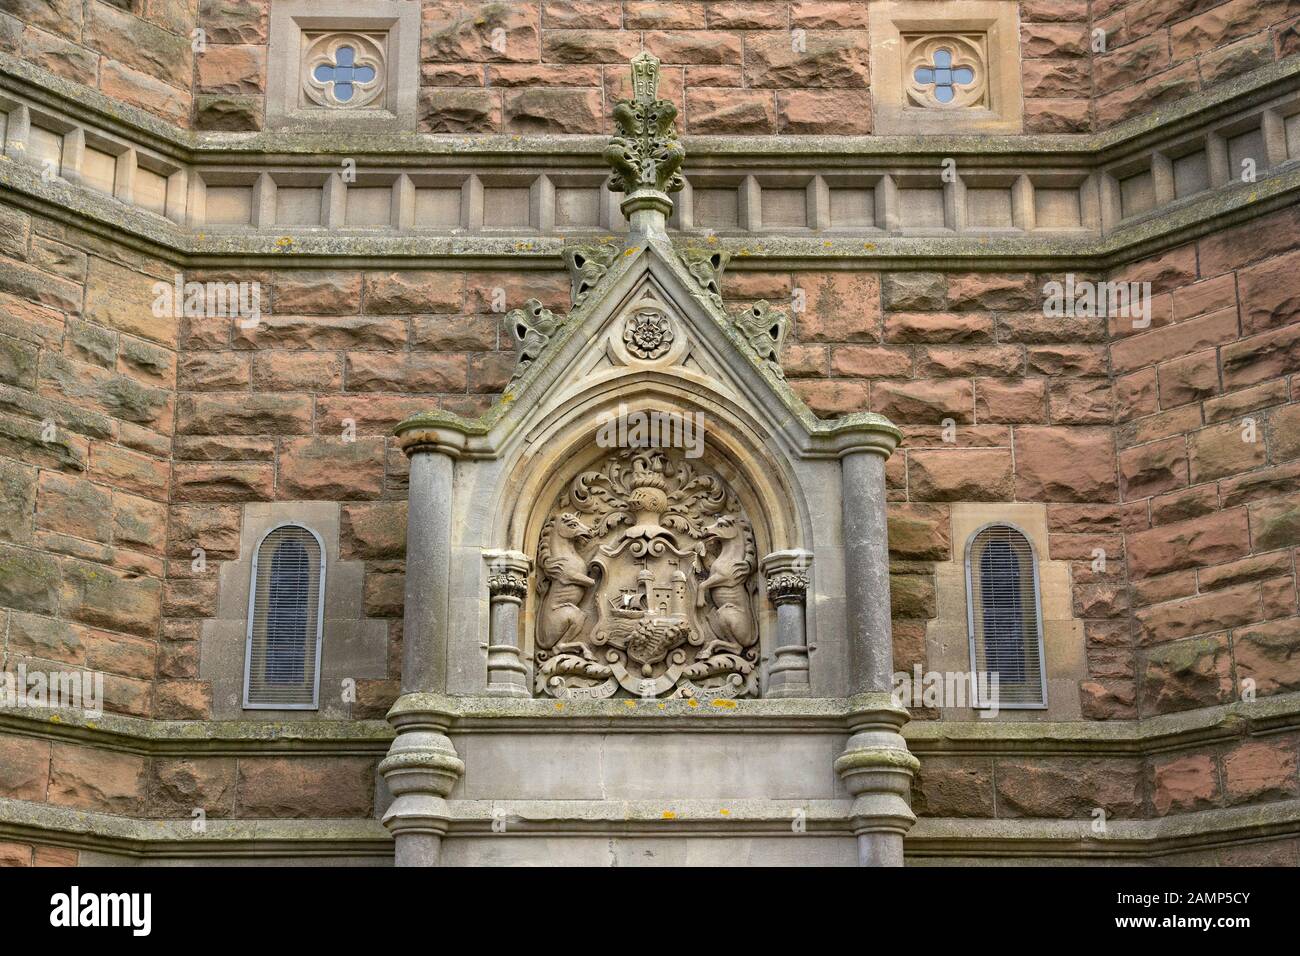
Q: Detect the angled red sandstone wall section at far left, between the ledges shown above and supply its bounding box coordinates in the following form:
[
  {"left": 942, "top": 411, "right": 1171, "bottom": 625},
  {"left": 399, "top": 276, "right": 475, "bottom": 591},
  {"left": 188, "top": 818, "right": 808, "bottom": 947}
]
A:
[{"left": 0, "top": 208, "right": 183, "bottom": 717}]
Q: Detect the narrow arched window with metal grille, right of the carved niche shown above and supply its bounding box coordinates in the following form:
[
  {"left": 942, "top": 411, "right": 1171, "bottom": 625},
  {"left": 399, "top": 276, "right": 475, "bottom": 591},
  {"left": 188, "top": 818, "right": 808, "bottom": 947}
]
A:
[{"left": 966, "top": 524, "right": 1048, "bottom": 709}]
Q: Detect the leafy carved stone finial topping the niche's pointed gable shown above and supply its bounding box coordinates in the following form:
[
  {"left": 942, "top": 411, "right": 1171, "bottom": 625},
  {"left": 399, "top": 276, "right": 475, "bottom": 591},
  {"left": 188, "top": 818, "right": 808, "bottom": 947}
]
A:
[{"left": 605, "top": 51, "right": 686, "bottom": 221}]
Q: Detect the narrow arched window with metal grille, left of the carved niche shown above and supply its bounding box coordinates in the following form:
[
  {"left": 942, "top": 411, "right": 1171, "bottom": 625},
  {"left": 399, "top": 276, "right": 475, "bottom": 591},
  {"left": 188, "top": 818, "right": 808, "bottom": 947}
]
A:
[{"left": 244, "top": 523, "right": 325, "bottom": 710}]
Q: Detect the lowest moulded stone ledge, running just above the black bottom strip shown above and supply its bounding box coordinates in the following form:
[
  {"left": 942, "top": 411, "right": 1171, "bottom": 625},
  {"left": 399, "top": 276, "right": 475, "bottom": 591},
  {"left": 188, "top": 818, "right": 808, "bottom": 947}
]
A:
[{"left": 0, "top": 799, "right": 1300, "bottom": 862}]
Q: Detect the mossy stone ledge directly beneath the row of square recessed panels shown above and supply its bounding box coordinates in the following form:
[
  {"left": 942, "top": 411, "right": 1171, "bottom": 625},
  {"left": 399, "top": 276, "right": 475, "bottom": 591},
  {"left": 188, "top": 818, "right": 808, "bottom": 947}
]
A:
[{"left": 0, "top": 159, "right": 1300, "bottom": 272}]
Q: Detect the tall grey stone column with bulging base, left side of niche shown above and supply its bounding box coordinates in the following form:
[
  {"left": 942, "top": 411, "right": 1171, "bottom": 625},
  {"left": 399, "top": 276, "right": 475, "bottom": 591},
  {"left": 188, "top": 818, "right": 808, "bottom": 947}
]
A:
[{"left": 380, "top": 412, "right": 464, "bottom": 866}]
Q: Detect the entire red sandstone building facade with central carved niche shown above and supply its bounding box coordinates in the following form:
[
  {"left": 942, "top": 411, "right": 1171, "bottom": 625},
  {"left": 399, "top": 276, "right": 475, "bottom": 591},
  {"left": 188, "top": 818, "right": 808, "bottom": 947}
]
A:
[{"left": 0, "top": 0, "right": 1300, "bottom": 865}]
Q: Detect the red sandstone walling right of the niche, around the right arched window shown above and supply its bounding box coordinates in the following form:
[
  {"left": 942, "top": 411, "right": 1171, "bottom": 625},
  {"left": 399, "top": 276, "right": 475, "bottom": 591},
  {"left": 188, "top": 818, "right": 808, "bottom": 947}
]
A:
[{"left": 725, "top": 209, "right": 1300, "bottom": 718}]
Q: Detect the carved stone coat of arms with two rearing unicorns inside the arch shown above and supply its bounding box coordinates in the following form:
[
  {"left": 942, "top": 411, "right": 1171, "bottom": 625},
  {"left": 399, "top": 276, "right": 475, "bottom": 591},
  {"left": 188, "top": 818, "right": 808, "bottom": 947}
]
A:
[{"left": 536, "top": 450, "right": 759, "bottom": 698}]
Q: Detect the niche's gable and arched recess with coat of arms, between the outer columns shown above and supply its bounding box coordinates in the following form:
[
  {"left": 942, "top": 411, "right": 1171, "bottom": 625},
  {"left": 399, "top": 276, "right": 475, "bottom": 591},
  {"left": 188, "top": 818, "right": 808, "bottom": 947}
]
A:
[{"left": 436, "top": 265, "right": 842, "bottom": 700}]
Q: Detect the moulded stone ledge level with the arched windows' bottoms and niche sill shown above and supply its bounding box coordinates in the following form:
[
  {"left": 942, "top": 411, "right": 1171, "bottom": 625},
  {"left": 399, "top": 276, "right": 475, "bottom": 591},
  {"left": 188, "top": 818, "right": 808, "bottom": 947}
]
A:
[{"left": 0, "top": 693, "right": 1300, "bottom": 760}]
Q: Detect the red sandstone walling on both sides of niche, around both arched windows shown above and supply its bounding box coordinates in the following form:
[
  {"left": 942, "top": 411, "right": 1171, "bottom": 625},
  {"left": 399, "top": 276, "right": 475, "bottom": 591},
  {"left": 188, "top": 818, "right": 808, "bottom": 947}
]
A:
[{"left": 0, "top": 204, "right": 1300, "bottom": 718}]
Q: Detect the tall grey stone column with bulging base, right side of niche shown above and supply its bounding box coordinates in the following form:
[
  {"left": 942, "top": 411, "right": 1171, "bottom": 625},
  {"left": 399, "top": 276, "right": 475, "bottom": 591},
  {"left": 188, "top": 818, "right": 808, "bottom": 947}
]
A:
[{"left": 835, "top": 426, "right": 919, "bottom": 866}]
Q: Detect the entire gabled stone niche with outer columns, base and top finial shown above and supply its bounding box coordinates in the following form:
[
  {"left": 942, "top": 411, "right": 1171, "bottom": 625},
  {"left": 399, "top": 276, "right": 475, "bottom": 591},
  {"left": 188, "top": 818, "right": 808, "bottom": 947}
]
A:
[{"left": 380, "top": 53, "right": 917, "bottom": 866}]
